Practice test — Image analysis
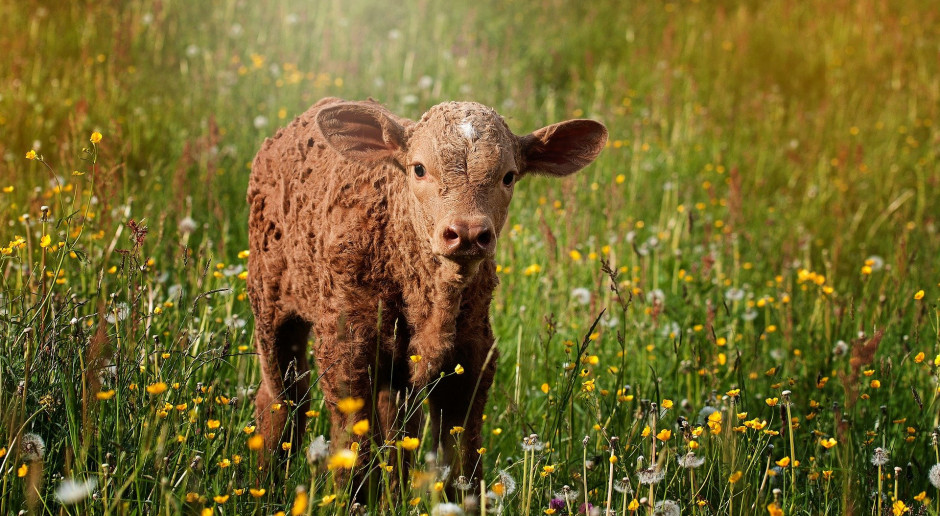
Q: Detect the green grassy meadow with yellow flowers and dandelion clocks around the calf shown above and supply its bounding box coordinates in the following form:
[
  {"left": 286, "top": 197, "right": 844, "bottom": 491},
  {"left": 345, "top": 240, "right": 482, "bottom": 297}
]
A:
[{"left": 0, "top": 0, "right": 940, "bottom": 515}]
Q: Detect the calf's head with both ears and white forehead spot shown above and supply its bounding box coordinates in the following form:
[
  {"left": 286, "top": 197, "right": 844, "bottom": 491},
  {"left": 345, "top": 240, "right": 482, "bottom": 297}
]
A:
[{"left": 317, "top": 102, "right": 607, "bottom": 265}]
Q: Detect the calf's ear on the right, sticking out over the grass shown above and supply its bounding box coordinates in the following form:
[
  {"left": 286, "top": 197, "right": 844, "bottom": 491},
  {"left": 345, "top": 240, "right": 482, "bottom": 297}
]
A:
[{"left": 519, "top": 119, "right": 607, "bottom": 177}]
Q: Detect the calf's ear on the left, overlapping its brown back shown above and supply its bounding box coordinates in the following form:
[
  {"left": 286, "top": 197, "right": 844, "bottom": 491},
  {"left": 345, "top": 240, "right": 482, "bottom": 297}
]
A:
[{"left": 316, "top": 102, "right": 405, "bottom": 161}]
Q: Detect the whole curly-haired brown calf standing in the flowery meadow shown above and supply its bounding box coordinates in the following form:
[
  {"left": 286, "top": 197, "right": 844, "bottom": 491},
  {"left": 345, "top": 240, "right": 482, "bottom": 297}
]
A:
[{"left": 248, "top": 98, "right": 607, "bottom": 496}]
